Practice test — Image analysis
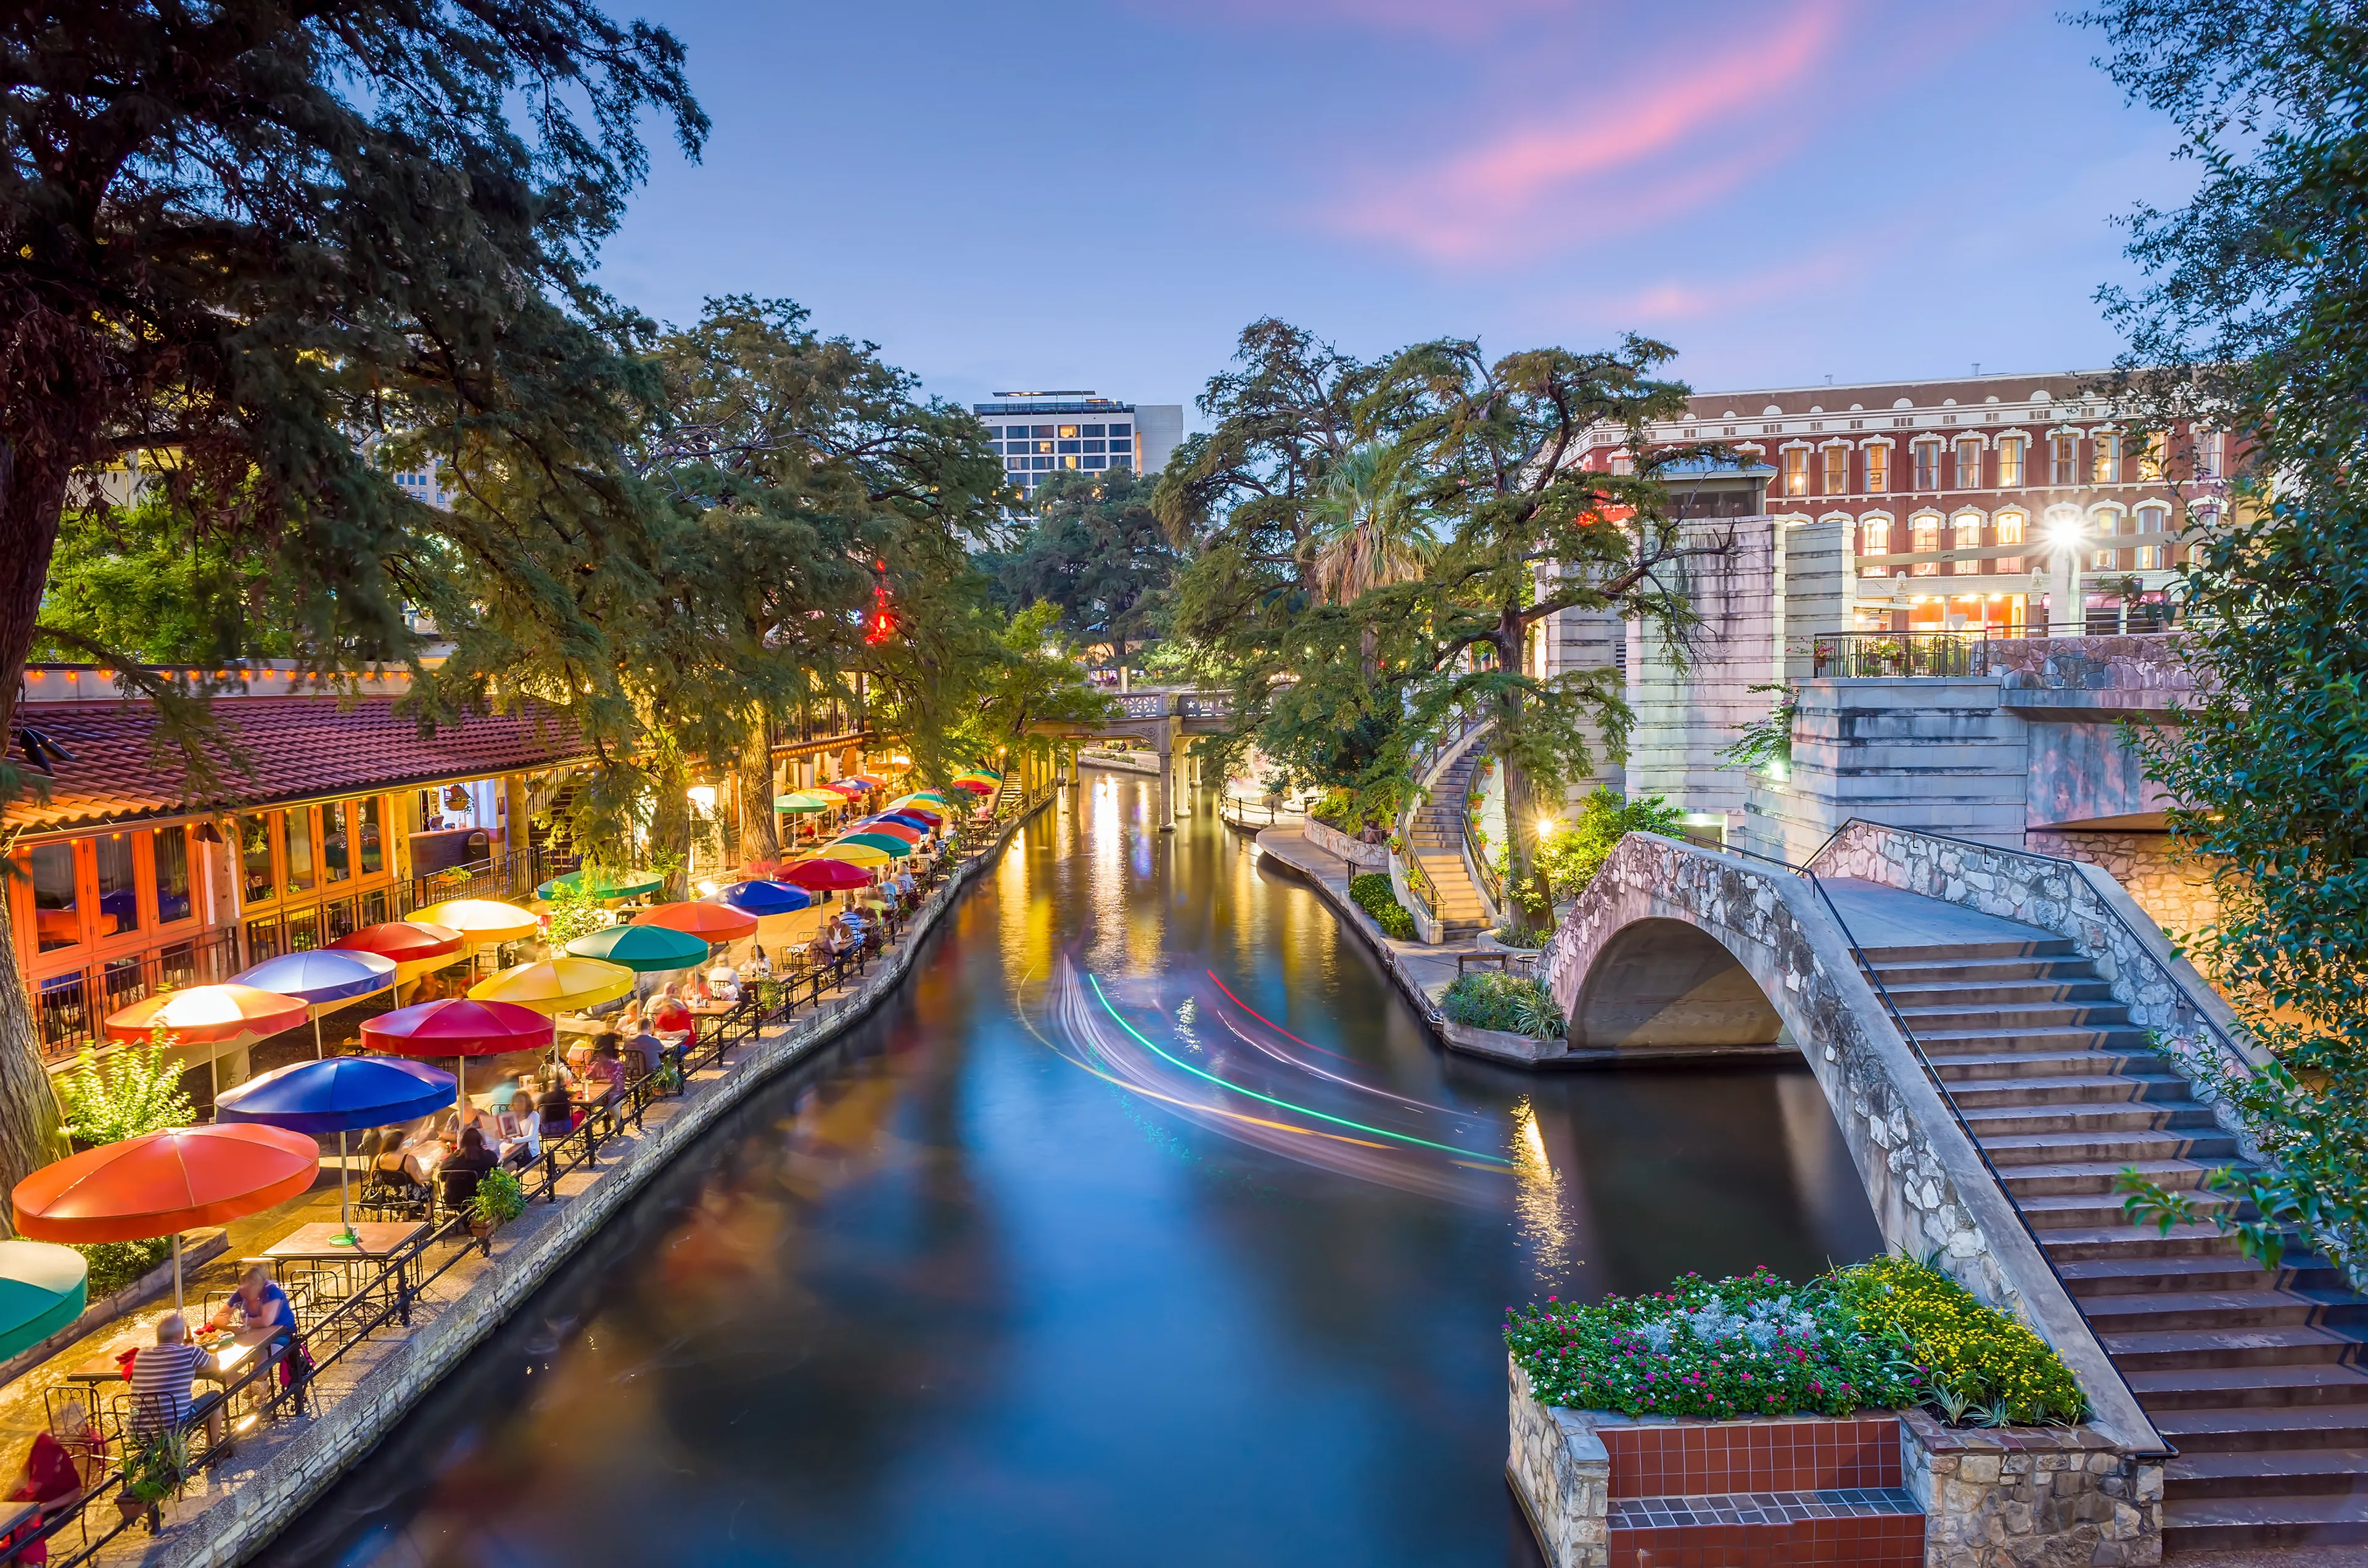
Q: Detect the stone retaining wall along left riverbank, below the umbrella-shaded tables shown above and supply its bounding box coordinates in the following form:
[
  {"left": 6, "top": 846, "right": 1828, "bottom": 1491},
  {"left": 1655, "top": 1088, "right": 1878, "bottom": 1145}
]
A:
[{"left": 162, "top": 794, "right": 1051, "bottom": 1568}]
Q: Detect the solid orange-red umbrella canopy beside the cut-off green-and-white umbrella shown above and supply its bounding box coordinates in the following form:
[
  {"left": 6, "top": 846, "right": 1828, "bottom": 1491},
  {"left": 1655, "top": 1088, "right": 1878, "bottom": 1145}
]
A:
[{"left": 9, "top": 1123, "right": 319, "bottom": 1244}]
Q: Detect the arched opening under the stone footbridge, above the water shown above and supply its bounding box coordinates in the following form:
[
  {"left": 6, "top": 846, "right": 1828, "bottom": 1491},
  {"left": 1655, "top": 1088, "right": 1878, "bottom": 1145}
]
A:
[{"left": 1570, "top": 917, "right": 1790, "bottom": 1049}]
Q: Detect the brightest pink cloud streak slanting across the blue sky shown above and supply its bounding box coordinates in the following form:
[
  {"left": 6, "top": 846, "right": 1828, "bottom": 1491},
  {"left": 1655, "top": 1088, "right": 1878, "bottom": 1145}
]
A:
[{"left": 1324, "top": 0, "right": 1844, "bottom": 263}]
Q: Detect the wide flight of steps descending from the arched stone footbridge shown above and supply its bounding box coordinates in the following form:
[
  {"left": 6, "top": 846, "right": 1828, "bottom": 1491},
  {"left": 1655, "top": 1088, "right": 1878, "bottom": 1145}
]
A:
[{"left": 1849, "top": 900, "right": 2368, "bottom": 1561}]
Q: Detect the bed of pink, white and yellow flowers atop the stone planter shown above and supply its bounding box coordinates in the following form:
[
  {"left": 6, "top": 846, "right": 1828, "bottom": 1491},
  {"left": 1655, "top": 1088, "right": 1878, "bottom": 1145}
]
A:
[{"left": 1503, "top": 1258, "right": 2086, "bottom": 1426}]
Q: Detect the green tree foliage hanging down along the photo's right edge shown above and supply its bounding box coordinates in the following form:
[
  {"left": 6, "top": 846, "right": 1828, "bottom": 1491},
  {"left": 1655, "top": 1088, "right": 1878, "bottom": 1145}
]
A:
[{"left": 2089, "top": 0, "right": 2368, "bottom": 1267}]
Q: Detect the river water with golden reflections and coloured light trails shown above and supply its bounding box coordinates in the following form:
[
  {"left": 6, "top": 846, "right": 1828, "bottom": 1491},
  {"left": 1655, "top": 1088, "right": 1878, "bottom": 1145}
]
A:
[{"left": 265, "top": 772, "right": 1880, "bottom": 1568}]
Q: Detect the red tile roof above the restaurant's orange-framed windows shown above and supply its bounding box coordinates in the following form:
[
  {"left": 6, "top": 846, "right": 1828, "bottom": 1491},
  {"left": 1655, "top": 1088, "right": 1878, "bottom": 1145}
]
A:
[{"left": 7, "top": 696, "right": 590, "bottom": 834}]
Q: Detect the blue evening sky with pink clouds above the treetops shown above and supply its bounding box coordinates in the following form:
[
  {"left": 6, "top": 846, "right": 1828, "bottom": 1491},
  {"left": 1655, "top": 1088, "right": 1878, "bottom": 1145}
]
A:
[{"left": 604, "top": 0, "right": 2193, "bottom": 426}]
